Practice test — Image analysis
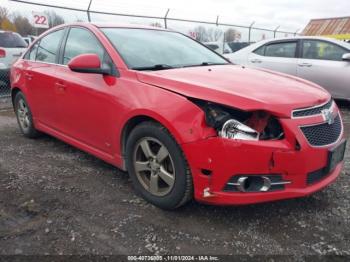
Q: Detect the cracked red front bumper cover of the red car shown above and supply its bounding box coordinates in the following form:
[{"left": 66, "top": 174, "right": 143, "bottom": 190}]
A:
[{"left": 182, "top": 110, "right": 344, "bottom": 205}]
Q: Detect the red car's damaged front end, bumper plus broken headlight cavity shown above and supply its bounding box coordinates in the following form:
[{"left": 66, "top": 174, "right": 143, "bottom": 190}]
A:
[{"left": 182, "top": 99, "right": 343, "bottom": 205}]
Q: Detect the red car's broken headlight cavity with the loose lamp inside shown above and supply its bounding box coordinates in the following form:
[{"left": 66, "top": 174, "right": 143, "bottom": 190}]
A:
[{"left": 190, "top": 99, "right": 284, "bottom": 141}]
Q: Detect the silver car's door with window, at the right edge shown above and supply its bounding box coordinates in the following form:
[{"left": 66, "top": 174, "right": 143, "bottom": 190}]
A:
[{"left": 297, "top": 39, "right": 350, "bottom": 99}]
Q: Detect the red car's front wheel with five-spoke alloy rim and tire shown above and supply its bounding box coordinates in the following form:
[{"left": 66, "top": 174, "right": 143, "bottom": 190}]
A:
[{"left": 126, "top": 122, "right": 193, "bottom": 210}]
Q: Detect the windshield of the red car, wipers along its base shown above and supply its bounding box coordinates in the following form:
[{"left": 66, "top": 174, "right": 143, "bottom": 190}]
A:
[{"left": 101, "top": 28, "right": 228, "bottom": 70}]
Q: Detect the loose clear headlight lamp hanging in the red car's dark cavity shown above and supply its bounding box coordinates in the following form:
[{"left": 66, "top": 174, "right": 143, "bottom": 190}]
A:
[{"left": 219, "top": 119, "right": 259, "bottom": 140}]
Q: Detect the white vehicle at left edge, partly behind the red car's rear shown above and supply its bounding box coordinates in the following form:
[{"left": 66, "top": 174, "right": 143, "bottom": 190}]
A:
[{"left": 0, "top": 31, "right": 28, "bottom": 88}]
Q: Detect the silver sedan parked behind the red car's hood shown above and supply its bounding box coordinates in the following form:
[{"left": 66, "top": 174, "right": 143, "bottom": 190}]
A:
[{"left": 225, "top": 37, "right": 350, "bottom": 101}]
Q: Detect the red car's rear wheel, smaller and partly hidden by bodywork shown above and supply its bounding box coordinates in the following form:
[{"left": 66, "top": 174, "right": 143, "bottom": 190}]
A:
[{"left": 14, "top": 92, "right": 40, "bottom": 138}]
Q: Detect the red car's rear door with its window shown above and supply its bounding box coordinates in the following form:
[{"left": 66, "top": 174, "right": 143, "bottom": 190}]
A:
[{"left": 24, "top": 29, "right": 65, "bottom": 129}]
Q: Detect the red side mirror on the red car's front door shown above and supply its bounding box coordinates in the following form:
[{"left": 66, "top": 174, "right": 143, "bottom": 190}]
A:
[{"left": 68, "top": 54, "right": 111, "bottom": 75}]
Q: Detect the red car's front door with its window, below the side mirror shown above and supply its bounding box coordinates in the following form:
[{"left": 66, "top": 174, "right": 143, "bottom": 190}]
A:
[{"left": 56, "top": 27, "right": 118, "bottom": 155}]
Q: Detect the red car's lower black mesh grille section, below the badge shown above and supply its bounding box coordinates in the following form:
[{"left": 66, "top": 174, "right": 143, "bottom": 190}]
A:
[{"left": 300, "top": 114, "right": 342, "bottom": 146}]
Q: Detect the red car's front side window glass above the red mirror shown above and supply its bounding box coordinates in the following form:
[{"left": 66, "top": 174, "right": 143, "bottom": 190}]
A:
[{"left": 63, "top": 28, "right": 105, "bottom": 65}]
